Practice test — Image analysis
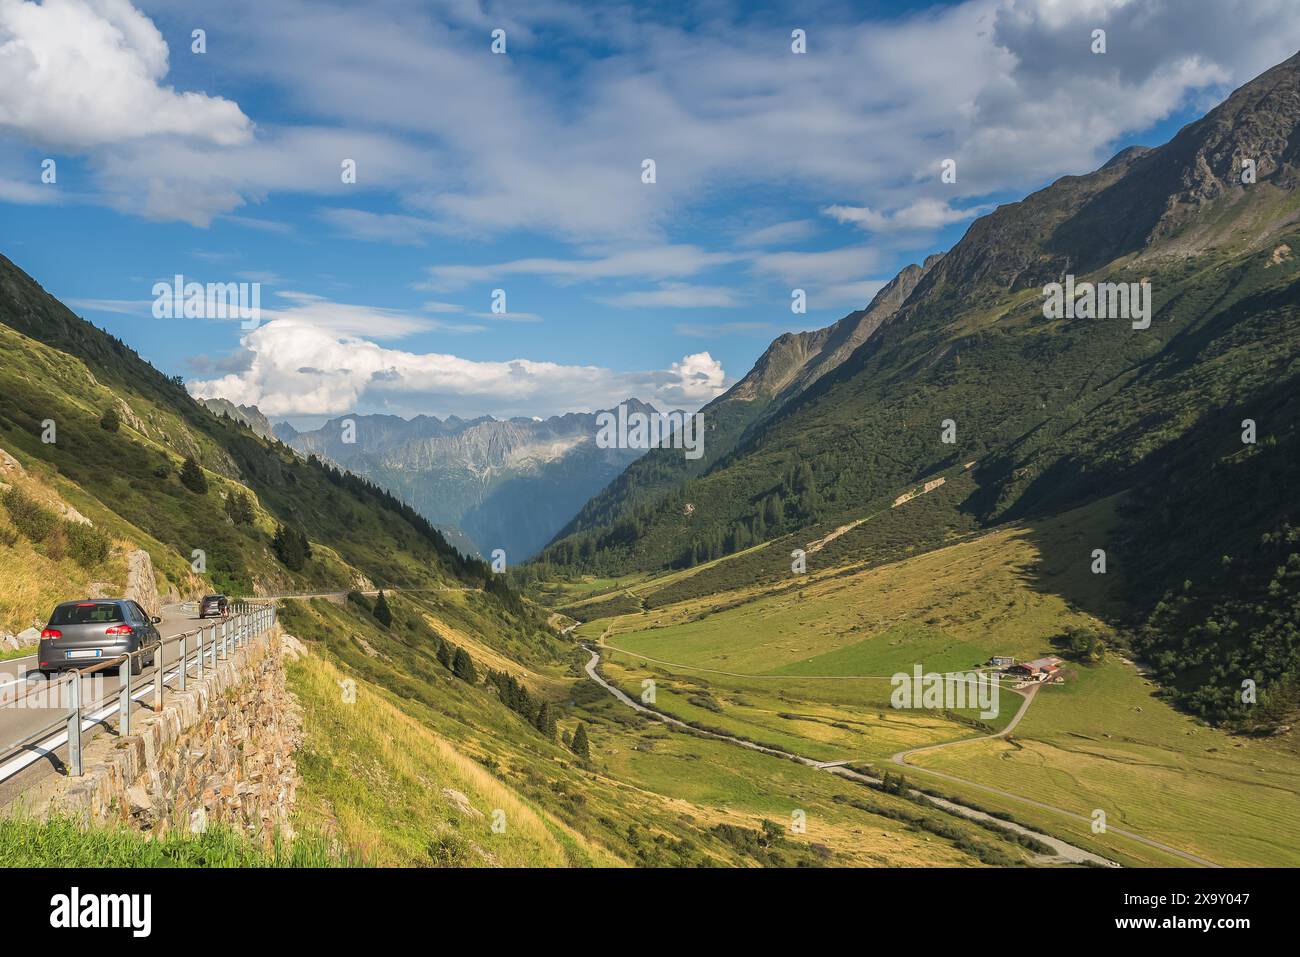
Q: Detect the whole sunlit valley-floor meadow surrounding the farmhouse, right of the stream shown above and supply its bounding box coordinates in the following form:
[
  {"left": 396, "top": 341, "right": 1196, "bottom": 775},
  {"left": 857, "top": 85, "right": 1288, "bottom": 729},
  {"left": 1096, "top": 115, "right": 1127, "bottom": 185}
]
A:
[{"left": 579, "top": 501, "right": 1300, "bottom": 866}]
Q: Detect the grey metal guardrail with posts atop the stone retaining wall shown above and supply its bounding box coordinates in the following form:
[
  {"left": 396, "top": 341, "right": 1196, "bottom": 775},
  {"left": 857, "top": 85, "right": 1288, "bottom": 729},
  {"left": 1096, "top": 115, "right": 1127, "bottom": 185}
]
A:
[{"left": 0, "top": 602, "right": 276, "bottom": 776}]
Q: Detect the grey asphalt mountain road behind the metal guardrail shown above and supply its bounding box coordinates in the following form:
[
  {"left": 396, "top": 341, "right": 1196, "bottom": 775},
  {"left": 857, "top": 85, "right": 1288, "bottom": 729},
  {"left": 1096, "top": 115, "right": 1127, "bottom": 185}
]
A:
[{"left": 0, "top": 605, "right": 230, "bottom": 806}]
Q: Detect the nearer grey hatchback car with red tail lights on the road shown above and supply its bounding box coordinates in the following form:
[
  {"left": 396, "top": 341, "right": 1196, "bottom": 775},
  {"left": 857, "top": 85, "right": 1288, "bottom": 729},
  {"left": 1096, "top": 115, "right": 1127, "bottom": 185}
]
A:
[{"left": 36, "top": 598, "right": 163, "bottom": 675}]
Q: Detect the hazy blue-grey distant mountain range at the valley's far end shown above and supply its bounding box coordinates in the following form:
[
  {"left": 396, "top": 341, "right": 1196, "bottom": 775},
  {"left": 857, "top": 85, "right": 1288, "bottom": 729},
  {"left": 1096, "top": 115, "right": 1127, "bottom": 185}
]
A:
[{"left": 274, "top": 399, "right": 655, "bottom": 563}]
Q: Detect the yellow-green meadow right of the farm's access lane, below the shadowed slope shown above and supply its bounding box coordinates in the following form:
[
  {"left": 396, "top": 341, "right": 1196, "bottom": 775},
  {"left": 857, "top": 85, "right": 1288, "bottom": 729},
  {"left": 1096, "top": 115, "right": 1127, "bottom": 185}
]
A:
[{"left": 909, "top": 658, "right": 1300, "bottom": 867}]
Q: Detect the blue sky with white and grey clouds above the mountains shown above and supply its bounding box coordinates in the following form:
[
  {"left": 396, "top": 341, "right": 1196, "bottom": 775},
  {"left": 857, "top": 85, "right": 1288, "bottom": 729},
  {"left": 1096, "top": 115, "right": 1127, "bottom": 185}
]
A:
[{"left": 0, "top": 0, "right": 1300, "bottom": 424}]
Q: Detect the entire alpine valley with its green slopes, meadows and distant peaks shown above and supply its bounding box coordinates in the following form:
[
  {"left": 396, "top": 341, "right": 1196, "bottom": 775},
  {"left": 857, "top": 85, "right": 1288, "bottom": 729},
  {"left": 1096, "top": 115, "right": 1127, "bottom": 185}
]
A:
[{"left": 0, "top": 35, "right": 1300, "bottom": 883}]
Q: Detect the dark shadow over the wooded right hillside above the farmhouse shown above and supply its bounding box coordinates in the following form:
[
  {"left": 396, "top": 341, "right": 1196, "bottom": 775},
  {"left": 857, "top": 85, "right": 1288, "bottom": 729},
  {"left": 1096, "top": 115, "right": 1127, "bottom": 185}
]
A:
[{"left": 979, "top": 369, "right": 1300, "bottom": 639}]
